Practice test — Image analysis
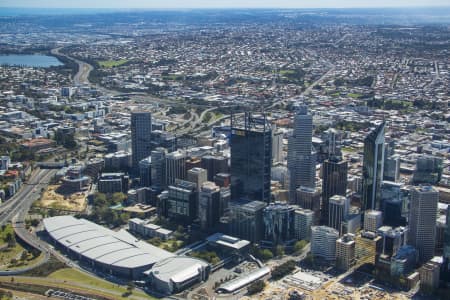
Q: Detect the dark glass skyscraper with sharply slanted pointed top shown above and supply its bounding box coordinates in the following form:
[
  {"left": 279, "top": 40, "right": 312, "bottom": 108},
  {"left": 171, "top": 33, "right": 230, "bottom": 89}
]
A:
[{"left": 361, "top": 122, "right": 385, "bottom": 210}]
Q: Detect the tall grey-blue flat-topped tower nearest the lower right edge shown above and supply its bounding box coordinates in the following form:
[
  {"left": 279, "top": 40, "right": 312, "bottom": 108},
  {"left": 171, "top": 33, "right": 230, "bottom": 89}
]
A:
[{"left": 408, "top": 186, "right": 439, "bottom": 263}]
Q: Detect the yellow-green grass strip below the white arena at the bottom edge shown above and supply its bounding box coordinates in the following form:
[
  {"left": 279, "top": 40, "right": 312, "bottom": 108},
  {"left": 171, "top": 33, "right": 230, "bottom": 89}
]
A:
[{"left": 47, "top": 268, "right": 154, "bottom": 299}]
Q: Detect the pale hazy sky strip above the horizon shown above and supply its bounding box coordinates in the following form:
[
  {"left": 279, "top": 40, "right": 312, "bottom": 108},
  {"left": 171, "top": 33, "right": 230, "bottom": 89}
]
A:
[{"left": 0, "top": 0, "right": 450, "bottom": 8}]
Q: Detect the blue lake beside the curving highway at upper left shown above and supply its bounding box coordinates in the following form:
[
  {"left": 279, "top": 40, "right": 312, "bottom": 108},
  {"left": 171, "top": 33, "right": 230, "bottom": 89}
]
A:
[{"left": 0, "top": 54, "right": 63, "bottom": 68}]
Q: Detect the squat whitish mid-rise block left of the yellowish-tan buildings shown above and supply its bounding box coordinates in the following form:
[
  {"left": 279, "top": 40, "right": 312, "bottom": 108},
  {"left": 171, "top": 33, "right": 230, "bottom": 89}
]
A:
[{"left": 311, "top": 226, "right": 339, "bottom": 261}]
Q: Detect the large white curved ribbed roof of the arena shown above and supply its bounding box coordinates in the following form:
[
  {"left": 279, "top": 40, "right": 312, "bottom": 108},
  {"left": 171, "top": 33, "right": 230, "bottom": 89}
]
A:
[{"left": 44, "top": 216, "right": 174, "bottom": 269}]
